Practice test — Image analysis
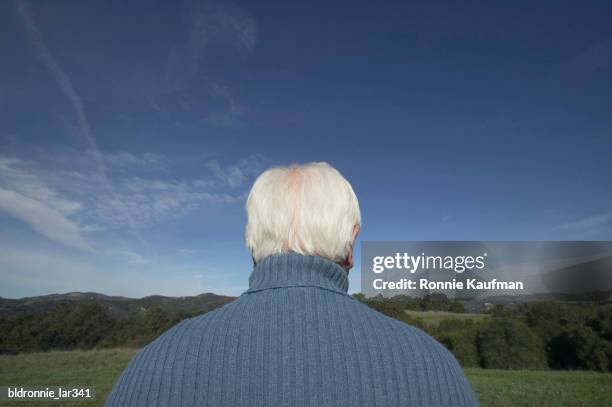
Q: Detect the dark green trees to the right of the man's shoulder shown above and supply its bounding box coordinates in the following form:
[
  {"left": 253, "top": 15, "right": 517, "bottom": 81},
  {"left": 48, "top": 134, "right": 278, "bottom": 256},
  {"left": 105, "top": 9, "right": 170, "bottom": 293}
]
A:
[{"left": 356, "top": 294, "right": 612, "bottom": 372}]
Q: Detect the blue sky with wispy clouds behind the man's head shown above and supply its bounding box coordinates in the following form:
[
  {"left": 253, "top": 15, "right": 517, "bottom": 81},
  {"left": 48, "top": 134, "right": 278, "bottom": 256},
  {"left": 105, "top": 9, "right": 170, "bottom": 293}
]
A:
[{"left": 0, "top": 0, "right": 612, "bottom": 298}]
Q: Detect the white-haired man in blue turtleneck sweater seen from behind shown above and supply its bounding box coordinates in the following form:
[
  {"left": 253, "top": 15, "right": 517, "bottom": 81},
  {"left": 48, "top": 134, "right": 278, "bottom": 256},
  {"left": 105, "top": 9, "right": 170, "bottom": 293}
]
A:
[{"left": 106, "top": 163, "right": 478, "bottom": 407}]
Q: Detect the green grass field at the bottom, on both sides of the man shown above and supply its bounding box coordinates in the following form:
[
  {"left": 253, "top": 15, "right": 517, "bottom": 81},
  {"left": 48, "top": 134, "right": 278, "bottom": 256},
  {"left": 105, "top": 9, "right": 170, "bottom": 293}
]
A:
[{"left": 0, "top": 349, "right": 612, "bottom": 407}]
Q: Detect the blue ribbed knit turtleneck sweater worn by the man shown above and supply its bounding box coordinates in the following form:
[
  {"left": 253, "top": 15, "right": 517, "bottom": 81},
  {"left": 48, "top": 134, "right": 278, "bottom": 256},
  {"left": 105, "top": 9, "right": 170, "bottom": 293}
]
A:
[{"left": 106, "top": 253, "right": 478, "bottom": 407}]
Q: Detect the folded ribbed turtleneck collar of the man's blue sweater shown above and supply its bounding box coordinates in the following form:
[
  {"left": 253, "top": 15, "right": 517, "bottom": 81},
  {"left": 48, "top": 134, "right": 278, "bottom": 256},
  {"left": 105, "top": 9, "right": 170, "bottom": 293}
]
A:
[{"left": 247, "top": 252, "right": 348, "bottom": 294}]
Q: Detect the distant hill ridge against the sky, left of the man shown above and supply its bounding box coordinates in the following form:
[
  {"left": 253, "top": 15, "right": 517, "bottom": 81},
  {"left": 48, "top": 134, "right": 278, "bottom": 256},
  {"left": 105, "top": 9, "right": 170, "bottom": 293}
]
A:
[{"left": 0, "top": 292, "right": 236, "bottom": 319}]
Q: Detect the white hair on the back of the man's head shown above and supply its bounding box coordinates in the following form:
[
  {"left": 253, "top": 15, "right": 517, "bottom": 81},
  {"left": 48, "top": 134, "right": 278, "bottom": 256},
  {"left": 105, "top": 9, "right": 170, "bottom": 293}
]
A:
[{"left": 245, "top": 162, "right": 361, "bottom": 262}]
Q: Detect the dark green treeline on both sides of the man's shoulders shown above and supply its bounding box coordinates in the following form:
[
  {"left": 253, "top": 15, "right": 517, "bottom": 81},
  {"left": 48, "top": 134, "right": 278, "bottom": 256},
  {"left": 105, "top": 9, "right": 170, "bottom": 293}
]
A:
[{"left": 0, "top": 294, "right": 612, "bottom": 372}]
